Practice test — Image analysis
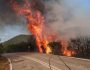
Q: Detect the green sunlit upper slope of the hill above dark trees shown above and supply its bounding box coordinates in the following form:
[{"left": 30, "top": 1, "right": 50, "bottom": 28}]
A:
[{"left": 3, "top": 35, "right": 33, "bottom": 46}]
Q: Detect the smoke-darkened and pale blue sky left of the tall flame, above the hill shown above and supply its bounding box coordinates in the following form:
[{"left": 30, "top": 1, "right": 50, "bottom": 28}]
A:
[{"left": 0, "top": 0, "right": 28, "bottom": 42}]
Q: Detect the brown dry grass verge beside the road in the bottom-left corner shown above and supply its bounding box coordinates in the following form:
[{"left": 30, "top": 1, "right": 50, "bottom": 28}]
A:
[{"left": 0, "top": 57, "right": 9, "bottom": 70}]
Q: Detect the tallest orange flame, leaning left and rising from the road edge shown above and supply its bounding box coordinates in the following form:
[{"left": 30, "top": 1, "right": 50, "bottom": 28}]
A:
[{"left": 12, "top": 0, "right": 51, "bottom": 54}]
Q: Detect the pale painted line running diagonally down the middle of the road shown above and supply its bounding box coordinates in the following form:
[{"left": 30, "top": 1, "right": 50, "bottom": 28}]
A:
[{"left": 22, "top": 56, "right": 61, "bottom": 70}]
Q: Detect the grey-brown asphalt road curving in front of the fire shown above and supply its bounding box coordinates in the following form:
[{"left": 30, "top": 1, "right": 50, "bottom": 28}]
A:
[{"left": 4, "top": 53, "right": 90, "bottom": 70}]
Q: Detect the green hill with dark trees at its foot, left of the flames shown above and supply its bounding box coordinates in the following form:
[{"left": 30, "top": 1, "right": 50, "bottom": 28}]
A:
[{"left": 3, "top": 35, "right": 37, "bottom": 52}]
